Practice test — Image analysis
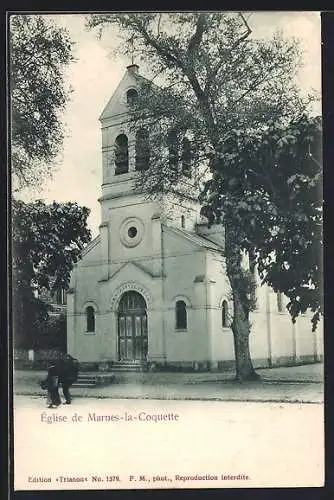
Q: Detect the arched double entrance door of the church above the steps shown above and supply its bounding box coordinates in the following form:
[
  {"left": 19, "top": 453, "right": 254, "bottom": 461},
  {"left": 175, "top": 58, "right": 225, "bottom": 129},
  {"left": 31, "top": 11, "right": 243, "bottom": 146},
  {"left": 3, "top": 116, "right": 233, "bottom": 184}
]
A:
[{"left": 118, "top": 291, "right": 147, "bottom": 361}]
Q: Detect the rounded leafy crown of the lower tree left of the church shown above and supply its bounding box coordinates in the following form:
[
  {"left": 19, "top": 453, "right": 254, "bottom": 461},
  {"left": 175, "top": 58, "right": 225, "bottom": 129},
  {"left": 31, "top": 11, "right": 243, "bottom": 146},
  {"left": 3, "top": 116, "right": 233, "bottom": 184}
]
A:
[{"left": 12, "top": 200, "right": 91, "bottom": 291}]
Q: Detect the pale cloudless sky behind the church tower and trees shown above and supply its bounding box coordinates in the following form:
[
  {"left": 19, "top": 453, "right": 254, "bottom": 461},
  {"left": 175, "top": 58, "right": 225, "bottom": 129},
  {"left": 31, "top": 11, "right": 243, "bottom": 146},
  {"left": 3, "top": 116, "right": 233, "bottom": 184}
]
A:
[{"left": 17, "top": 11, "right": 321, "bottom": 236}]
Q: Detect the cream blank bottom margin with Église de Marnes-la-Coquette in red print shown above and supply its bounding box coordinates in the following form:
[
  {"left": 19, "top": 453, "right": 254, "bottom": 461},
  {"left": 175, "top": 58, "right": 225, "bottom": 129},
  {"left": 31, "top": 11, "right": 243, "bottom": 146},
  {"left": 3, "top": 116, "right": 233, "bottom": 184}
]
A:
[{"left": 14, "top": 396, "right": 324, "bottom": 490}]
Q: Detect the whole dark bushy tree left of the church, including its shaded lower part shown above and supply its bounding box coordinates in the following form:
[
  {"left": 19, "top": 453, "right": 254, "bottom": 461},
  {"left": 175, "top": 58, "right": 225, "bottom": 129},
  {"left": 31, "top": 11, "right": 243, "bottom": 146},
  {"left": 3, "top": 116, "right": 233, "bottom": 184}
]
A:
[{"left": 12, "top": 200, "right": 91, "bottom": 348}]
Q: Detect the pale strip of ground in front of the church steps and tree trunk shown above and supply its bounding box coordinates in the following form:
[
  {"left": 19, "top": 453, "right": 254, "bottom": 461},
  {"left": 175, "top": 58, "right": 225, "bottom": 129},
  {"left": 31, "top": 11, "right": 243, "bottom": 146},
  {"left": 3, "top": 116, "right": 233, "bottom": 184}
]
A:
[{"left": 13, "top": 363, "right": 324, "bottom": 403}]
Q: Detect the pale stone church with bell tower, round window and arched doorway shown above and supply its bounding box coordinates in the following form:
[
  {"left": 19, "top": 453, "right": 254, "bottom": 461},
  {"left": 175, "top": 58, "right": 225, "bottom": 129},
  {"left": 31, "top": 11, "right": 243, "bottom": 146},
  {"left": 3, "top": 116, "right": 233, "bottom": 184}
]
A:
[{"left": 67, "top": 64, "right": 323, "bottom": 371}]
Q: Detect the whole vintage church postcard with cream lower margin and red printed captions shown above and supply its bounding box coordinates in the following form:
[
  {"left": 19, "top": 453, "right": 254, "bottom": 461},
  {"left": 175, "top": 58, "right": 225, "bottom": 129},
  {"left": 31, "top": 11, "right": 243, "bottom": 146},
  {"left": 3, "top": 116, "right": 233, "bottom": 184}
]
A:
[{"left": 8, "top": 11, "right": 324, "bottom": 491}]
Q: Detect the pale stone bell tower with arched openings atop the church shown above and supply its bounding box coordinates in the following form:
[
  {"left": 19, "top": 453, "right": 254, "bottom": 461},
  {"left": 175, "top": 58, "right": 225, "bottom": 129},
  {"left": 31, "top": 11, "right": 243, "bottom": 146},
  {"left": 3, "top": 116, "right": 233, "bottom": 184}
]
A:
[{"left": 99, "top": 64, "right": 199, "bottom": 278}]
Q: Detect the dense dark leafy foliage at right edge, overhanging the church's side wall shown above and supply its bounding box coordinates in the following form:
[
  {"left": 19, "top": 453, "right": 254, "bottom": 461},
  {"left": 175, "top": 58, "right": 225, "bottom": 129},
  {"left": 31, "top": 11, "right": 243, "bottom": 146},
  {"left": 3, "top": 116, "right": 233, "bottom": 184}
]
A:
[{"left": 201, "top": 115, "right": 323, "bottom": 330}]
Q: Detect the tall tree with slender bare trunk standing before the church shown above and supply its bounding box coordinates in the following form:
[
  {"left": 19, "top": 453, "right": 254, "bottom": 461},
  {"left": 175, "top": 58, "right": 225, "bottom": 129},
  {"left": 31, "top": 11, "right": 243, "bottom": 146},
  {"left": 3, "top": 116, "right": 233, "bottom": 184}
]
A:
[{"left": 88, "top": 13, "right": 321, "bottom": 381}]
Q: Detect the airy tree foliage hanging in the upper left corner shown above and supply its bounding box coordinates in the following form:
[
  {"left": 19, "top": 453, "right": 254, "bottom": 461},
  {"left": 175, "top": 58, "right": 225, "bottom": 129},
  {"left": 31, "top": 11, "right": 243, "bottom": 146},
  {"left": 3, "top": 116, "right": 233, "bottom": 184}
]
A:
[{"left": 9, "top": 15, "right": 74, "bottom": 189}]
